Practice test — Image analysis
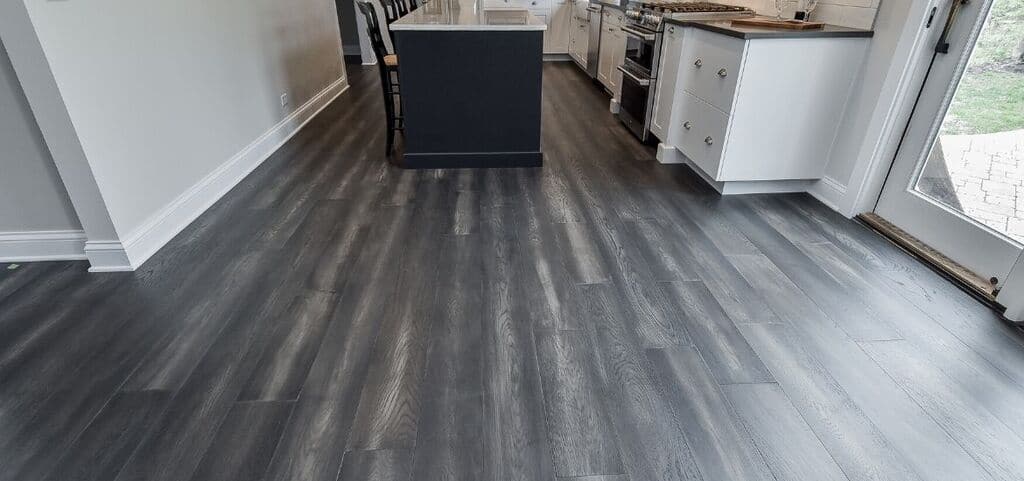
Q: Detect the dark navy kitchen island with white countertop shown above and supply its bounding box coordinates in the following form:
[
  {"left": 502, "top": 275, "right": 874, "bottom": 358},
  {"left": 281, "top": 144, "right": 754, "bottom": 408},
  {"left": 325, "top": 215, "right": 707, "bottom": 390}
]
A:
[{"left": 390, "top": 0, "right": 546, "bottom": 169}]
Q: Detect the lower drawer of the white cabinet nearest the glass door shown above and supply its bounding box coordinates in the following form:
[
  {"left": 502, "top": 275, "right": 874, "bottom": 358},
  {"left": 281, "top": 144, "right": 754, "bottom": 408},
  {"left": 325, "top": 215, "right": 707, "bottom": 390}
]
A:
[{"left": 674, "top": 92, "right": 729, "bottom": 179}]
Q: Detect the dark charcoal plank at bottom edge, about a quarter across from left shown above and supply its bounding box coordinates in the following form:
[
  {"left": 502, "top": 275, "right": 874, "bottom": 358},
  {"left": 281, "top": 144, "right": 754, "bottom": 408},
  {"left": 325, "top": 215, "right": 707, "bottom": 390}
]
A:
[{"left": 191, "top": 401, "right": 293, "bottom": 481}]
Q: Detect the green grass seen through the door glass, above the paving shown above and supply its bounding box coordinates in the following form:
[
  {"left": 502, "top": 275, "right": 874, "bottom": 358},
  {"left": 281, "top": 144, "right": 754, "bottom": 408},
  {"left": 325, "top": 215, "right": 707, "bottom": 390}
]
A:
[{"left": 943, "top": 0, "right": 1024, "bottom": 134}]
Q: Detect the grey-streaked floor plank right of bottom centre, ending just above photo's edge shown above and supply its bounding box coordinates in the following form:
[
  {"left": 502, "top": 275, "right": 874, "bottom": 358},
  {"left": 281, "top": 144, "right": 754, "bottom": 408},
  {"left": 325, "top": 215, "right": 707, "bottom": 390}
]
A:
[{"left": 535, "top": 330, "right": 623, "bottom": 477}]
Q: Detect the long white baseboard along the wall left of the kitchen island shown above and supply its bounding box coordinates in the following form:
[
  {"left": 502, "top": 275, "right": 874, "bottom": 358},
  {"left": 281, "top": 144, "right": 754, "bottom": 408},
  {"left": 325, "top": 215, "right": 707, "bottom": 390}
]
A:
[{"left": 92, "top": 77, "right": 348, "bottom": 272}]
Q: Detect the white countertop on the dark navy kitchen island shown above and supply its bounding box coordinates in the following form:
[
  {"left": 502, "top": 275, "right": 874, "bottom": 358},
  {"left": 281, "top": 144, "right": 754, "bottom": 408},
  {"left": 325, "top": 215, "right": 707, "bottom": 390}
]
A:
[{"left": 388, "top": 0, "right": 548, "bottom": 32}]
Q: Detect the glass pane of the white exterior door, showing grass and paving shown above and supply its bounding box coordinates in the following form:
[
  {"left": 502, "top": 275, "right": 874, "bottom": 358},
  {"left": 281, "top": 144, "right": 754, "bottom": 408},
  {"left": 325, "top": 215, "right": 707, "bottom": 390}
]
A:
[{"left": 915, "top": 0, "right": 1024, "bottom": 243}]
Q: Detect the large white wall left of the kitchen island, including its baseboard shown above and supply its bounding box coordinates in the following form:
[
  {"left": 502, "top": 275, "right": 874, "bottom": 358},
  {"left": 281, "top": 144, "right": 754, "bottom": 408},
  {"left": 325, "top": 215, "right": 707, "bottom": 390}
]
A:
[{"left": 0, "top": 0, "right": 347, "bottom": 270}]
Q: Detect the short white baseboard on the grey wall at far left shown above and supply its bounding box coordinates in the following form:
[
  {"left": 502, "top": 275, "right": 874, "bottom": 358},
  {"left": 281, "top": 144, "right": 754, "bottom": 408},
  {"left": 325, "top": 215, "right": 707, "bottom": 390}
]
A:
[{"left": 0, "top": 230, "right": 86, "bottom": 262}]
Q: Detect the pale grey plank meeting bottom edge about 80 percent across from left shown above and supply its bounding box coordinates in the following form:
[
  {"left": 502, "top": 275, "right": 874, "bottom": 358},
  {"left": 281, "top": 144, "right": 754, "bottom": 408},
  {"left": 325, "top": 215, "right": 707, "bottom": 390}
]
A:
[{"left": 722, "top": 384, "right": 847, "bottom": 481}]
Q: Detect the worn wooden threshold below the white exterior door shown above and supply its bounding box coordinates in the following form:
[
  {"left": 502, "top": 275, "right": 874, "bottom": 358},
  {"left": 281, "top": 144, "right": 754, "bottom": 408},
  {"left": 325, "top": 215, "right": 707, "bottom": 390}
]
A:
[{"left": 857, "top": 212, "right": 1001, "bottom": 302}]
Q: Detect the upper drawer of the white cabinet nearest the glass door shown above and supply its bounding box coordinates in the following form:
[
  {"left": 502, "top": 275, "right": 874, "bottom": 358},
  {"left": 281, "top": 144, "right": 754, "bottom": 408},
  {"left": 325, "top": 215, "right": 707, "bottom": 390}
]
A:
[{"left": 680, "top": 29, "right": 745, "bottom": 114}]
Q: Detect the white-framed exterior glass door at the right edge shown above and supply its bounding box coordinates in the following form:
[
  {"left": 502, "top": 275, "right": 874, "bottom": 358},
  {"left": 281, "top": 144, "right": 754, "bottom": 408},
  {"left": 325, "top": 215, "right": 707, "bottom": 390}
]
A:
[{"left": 876, "top": 0, "right": 1024, "bottom": 296}]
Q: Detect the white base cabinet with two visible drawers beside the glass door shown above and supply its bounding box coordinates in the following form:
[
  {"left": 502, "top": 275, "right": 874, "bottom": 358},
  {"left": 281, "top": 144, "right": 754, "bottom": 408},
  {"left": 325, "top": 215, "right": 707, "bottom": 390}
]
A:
[{"left": 651, "top": 26, "right": 868, "bottom": 188}]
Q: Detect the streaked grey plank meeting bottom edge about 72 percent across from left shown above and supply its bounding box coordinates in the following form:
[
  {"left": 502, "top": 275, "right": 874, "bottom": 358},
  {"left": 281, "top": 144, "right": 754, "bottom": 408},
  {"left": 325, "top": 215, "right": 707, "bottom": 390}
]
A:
[{"left": 647, "top": 347, "right": 773, "bottom": 480}]
